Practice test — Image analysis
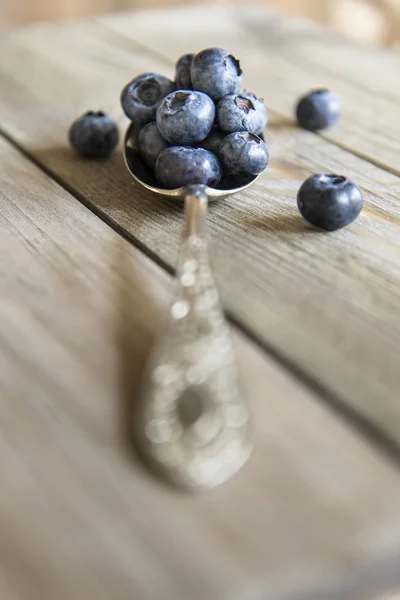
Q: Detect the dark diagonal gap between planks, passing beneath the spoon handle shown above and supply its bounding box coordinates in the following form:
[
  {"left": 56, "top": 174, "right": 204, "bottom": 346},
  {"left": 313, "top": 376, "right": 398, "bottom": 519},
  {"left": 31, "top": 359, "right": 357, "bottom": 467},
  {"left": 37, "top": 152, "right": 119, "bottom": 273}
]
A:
[{"left": 0, "top": 127, "right": 400, "bottom": 468}]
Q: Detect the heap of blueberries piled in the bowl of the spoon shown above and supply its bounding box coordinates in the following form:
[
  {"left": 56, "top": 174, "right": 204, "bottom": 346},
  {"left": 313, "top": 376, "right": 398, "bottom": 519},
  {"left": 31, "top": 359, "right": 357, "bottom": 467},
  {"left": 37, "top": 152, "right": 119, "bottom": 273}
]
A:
[{"left": 121, "top": 48, "right": 269, "bottom": 189}]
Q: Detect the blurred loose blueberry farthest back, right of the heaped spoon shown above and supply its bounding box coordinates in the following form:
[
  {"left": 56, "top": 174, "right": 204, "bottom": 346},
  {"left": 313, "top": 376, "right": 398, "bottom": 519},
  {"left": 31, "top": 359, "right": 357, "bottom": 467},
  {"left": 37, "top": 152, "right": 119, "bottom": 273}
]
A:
[{"left": 296, "top": 89, "right": 342, "bottom": 131}]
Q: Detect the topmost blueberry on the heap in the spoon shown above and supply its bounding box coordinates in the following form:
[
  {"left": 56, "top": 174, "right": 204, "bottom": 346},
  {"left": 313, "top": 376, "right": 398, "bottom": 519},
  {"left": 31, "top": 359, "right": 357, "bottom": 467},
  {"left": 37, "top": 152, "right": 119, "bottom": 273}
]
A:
[{"left": 190, "top": 48, "right": 242, "bottom": 102}]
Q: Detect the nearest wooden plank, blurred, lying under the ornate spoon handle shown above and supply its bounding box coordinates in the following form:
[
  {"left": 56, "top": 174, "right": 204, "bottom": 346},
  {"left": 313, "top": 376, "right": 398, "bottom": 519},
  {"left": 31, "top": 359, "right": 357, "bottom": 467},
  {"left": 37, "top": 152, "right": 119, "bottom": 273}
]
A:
[{"left": 0, "top": 140, "right": 400, "bottom": 600}]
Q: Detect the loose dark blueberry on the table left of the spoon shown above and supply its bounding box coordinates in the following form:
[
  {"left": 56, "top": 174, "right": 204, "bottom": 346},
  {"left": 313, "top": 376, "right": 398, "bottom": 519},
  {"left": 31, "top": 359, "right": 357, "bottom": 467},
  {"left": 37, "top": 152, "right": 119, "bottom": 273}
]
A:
[{"left": 69, "top": 111, "right": 119, "bottom": 158}]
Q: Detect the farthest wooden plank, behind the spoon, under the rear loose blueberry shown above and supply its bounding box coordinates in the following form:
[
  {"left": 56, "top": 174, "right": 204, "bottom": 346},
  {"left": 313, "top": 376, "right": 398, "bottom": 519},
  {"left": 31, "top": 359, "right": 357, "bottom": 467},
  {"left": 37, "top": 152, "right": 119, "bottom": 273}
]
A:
[{"left": 99, "top": 4, "right": 400, "bottom": 174}]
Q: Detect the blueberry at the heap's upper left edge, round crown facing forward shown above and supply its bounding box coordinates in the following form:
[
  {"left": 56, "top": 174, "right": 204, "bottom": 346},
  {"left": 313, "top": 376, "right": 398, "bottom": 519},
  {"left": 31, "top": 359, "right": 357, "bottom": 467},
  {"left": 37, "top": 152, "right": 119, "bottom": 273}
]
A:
[{"left": 121, "top": 73, "right": 176, "bottom": 125}]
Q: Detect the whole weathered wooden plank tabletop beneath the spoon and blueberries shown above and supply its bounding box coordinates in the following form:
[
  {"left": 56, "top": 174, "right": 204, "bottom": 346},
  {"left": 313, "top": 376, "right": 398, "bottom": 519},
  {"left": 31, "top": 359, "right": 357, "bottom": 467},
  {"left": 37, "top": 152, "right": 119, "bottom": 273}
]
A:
[{"left": 0, "top": 4, "right": 400, "bottom": 600}]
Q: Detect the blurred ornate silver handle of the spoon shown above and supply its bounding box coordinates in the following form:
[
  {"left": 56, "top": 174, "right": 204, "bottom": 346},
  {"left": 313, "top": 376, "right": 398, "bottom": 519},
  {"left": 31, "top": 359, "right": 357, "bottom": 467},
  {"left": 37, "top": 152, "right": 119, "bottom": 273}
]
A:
[{"left": 138, "top": 186, "right": 251, "bottom": 490}]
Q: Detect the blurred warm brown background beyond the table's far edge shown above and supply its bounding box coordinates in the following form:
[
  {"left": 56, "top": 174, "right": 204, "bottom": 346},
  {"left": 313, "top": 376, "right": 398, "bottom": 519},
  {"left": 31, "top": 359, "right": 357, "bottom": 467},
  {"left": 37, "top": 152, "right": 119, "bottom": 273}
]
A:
[{"left": 0, "top": 0, "right": 400, "bottom": 47}]
